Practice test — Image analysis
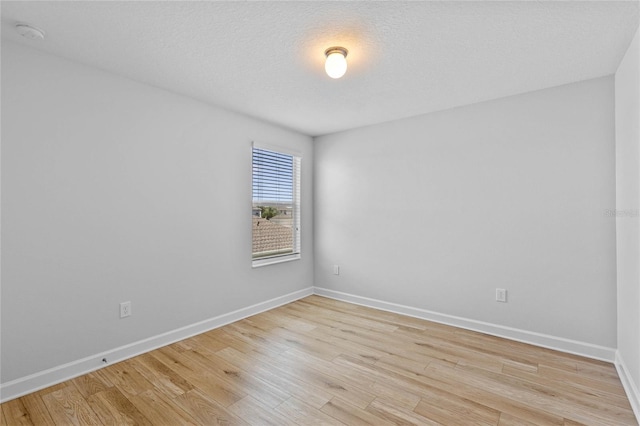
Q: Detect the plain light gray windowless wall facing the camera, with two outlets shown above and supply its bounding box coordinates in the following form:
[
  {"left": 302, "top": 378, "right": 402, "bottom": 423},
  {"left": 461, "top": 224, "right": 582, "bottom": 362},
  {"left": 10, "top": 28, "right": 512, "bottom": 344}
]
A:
[{"left": 314, "top": 76, "right": 616, "bottom": 352}]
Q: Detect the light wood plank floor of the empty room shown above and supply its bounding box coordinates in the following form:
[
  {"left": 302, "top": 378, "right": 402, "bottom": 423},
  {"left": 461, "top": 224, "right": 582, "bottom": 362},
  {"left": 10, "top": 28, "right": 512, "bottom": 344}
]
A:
[{"left": 1, "top": 296, "right": 637, "bottom": 426}]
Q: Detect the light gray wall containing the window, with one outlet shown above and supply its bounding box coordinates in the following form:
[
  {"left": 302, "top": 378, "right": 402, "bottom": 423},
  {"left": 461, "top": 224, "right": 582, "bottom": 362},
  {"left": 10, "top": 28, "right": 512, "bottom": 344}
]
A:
[{"left": 1, "top": 42, "right": 313, "bottom": 383}]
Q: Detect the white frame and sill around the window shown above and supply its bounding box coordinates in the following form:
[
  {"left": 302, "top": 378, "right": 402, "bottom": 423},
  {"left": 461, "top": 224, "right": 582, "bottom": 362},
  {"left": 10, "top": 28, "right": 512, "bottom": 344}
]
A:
[{"left": 251, "top": 142, "right": 302, "bottom": 268}]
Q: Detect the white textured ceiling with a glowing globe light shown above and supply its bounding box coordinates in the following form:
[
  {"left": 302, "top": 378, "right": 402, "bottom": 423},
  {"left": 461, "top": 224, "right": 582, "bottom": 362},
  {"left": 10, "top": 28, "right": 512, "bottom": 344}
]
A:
[{"left": 1, "top": 0, "right": 639, "bottom": 136}]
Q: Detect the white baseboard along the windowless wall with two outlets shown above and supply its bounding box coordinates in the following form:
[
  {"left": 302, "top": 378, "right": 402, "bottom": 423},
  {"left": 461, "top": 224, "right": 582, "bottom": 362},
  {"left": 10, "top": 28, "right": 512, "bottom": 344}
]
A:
[{"left": 314, "top": 287, "right": 616, "bottom": 362}]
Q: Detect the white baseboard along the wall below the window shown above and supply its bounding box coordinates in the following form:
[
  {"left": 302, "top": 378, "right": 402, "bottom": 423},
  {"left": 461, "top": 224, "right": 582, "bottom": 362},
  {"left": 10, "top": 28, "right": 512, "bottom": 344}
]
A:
[{"left": 0, "top": 287, "right": 313, "bottom": 402}]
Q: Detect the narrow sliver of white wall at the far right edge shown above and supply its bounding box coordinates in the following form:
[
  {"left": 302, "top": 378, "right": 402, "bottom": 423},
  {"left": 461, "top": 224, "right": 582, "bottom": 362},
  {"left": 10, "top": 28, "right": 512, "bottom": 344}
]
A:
[{"left": 615, "top": 26, "right": 640, "bottom": 417}]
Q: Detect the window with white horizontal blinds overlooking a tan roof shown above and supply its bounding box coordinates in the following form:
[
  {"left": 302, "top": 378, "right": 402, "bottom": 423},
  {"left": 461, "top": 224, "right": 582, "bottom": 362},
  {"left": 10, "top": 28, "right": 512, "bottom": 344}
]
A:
[{"left": 251, "top": 145, "right": 301, "bottom": 266}]
